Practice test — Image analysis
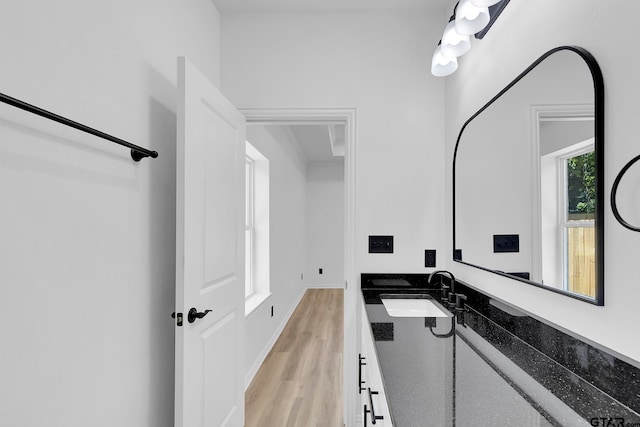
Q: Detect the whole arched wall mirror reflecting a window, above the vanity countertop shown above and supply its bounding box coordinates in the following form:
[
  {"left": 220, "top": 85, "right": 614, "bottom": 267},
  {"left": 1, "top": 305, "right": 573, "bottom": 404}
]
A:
[{"left": 453, "top": 46, "right": 604, "bottom": 305}]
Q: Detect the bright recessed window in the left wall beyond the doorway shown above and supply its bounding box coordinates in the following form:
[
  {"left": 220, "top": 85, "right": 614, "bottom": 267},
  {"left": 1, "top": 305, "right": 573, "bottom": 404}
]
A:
[{"left": 244, "top": 142, "right": 270, "bottom": 314}]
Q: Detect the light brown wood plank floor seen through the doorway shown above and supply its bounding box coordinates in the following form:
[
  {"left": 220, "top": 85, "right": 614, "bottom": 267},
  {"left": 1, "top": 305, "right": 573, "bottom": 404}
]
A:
[{"left": 245, "top": 289, "right": 344, "bottom": 427}]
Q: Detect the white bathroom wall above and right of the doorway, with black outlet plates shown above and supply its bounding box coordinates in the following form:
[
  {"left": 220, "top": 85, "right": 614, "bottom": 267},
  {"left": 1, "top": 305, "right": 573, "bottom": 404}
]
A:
[{"left": 221, "top": 12, "right": 445, "bottom": 273}]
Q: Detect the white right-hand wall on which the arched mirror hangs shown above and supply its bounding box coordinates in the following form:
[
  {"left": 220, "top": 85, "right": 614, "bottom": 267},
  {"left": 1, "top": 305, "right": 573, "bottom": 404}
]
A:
[{"left": 445, "top": 0, "right": 640, "bottom": 361}]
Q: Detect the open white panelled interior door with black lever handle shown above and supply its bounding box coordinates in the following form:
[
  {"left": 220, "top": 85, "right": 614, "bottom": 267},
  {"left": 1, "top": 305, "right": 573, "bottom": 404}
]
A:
[{"left": 175, "top": 58, "right": 245, "bottom": 427}]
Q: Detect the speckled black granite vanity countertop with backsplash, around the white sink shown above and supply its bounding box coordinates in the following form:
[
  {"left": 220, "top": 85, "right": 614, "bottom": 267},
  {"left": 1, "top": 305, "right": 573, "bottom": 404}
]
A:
[{"left": 362, "top": 274, "right": 640, "bottom": 427}]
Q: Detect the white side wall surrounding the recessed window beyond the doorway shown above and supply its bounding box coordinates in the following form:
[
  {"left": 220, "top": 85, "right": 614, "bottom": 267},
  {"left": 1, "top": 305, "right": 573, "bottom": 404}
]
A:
[{"left": 245, "top": 125, "right": 307, "bottom": 381}]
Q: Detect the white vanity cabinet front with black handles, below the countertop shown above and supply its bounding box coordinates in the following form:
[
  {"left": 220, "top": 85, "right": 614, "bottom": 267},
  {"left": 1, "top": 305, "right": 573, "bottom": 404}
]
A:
[{"left": 358, "top": 303, "right": 393, "bottom": 427}]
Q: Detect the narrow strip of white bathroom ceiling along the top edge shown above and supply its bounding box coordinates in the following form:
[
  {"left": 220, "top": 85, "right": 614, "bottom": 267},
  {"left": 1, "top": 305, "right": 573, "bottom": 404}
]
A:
[{"left": 213, "top": 0, "right": 449, "bottom": 13}]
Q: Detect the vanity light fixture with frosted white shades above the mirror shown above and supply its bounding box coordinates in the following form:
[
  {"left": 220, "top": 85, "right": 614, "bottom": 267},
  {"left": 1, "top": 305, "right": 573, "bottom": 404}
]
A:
[{"left": 431, "top": 0, "right": 509, "bottom": 77}]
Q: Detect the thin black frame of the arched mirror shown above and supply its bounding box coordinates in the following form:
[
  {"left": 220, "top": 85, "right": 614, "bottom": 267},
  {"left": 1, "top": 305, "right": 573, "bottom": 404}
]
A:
[{"left": 452, "top": 46, "right": 605, "bottom": 306}]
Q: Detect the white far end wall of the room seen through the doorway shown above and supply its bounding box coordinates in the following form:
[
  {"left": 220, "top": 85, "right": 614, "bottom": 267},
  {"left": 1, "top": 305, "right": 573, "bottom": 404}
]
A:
[{"left": 305, "top": 162, "right": 344, "bottom": 287}]
